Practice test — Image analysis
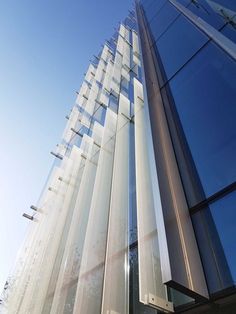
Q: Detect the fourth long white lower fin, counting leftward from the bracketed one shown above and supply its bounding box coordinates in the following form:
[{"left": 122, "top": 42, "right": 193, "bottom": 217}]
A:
[{"left": 50, "top": 143, "right": 99, "bottom": 314}]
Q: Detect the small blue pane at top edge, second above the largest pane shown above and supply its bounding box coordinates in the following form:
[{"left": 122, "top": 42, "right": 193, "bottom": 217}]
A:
[{"left": 149, "top": 2, "right": 180, "bottom": 41}]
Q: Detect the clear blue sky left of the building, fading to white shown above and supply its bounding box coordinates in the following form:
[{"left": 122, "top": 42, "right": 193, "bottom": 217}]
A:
[{"left": 0, "top": 0, "right": 132, "bottom": 293}]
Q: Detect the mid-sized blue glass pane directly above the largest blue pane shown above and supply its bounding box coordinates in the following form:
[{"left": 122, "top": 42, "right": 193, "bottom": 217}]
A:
[{"left": 154, "top": 16, "right": 208, "bottom": 78}]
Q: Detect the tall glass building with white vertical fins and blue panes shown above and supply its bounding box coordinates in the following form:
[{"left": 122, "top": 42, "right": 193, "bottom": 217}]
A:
[{"left": 0, "top": 0, "right": 236, "bottom": 314}]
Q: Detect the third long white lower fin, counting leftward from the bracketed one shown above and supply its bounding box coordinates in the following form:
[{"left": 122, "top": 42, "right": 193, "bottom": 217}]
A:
[{"left": 74, "top": 109, "right": 117, "bottom": 314}]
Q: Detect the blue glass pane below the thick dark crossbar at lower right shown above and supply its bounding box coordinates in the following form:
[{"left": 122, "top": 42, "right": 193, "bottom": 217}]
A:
[{"left": 193, "top": 192, "right": 236, "bottom": 292}]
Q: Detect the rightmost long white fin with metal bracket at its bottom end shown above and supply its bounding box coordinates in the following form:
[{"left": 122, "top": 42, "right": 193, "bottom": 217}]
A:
[{"left": 134, "top": 80, "right": 173, "bottom": 312}]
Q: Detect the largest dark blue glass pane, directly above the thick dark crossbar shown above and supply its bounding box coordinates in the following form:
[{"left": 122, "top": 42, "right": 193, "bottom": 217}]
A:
[{"left": 170, "top": 44, "right": 236, "bottom": 197}]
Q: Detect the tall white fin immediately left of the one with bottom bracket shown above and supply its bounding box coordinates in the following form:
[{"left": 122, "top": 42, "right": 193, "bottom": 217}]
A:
[{"left": 101, "top": 95, "right": 130, "bottom": 314}]
